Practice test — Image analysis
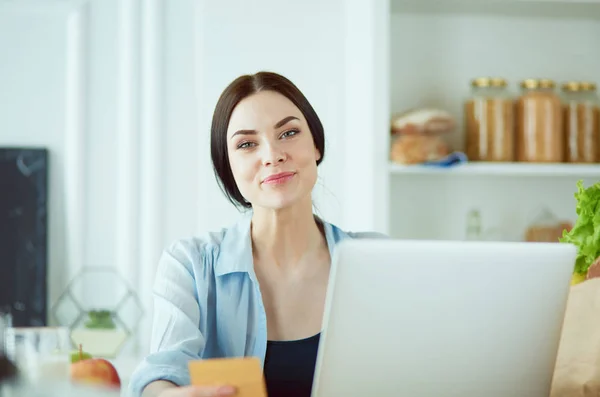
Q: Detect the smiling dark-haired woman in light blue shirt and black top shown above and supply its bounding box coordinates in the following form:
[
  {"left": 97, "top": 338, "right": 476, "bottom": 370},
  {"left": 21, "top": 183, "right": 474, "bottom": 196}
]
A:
[{"left": 131, "top": 72, "right": 386, "bottom": 397}]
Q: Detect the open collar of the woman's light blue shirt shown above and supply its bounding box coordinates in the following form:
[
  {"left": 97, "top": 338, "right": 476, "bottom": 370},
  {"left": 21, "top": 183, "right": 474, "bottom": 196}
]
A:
[{"left": 215, "top": 211, "right": 348, "bottom": 279}]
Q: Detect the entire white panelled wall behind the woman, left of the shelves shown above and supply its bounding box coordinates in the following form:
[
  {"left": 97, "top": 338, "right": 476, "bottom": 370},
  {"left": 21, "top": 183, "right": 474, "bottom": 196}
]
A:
[{"left": 0, "top": 0, "right": 387, "bottom": 356}]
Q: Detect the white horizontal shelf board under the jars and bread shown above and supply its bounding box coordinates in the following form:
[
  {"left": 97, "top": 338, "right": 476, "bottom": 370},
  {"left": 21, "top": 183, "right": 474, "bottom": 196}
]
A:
[{"left": 389, "top": 162, "right": 600, "bottom": 178}]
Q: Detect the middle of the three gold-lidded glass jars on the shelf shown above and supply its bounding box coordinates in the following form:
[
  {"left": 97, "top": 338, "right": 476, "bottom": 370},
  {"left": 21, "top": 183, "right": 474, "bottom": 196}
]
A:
[{"left": 516, "top": 79, "right": 564, "bottom": 163}]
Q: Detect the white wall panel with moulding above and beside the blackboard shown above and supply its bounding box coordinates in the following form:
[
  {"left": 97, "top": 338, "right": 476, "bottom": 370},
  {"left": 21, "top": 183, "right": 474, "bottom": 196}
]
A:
[{"left": 0, "top": 2, "right": 86, "bottom": 322}]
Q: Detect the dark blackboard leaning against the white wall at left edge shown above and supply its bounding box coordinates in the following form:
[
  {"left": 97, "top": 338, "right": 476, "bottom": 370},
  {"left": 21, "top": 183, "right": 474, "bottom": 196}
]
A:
[{"left": 0, "top": 147, "right": 48, "bottom": 326}]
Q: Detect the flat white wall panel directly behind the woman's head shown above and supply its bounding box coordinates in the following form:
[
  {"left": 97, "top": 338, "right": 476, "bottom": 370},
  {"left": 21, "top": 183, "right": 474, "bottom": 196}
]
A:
[{"left": 196, "top": 0, "right": 344, "bottom": 229}]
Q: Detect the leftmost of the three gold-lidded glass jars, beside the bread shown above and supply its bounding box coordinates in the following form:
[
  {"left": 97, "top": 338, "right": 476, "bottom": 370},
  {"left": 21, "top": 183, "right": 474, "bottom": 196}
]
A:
[{"left": 464, "top": 77, "right": 515, "bottom": 161}]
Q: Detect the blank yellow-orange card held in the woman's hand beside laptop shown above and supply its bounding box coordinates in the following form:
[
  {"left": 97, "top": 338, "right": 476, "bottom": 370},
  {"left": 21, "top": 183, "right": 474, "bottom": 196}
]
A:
[{"left": 188, "top": 357, "right": 267, "bottom": 397}]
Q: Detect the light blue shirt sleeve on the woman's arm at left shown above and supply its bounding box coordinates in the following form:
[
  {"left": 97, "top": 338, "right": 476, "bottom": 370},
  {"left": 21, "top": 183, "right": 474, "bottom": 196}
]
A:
[{"left": 129, "top": 243, "right": 205, "bottom": 397}]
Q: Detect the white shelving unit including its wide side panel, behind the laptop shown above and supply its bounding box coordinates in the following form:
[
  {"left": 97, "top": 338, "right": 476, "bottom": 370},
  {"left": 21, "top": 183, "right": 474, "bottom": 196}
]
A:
[{"left": 344, "top": 0, "right": 600, "bottom": 240}]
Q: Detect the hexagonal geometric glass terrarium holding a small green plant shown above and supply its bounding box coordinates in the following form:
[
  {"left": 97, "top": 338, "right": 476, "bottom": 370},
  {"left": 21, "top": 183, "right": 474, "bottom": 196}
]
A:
[{"left": 52, "top": 266, "right": 144, "bottom": 357}]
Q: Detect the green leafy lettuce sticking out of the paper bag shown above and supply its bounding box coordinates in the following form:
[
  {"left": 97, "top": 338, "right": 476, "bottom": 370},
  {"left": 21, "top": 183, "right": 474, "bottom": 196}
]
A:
[{"left": 560, "top": 181, "right": 600, "bottom": 274}]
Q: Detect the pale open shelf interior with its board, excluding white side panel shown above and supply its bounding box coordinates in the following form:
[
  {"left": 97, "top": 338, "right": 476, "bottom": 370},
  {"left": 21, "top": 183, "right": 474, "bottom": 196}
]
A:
[{"left": 388, "top": 0, "right": 600, "bottom": 240}]
